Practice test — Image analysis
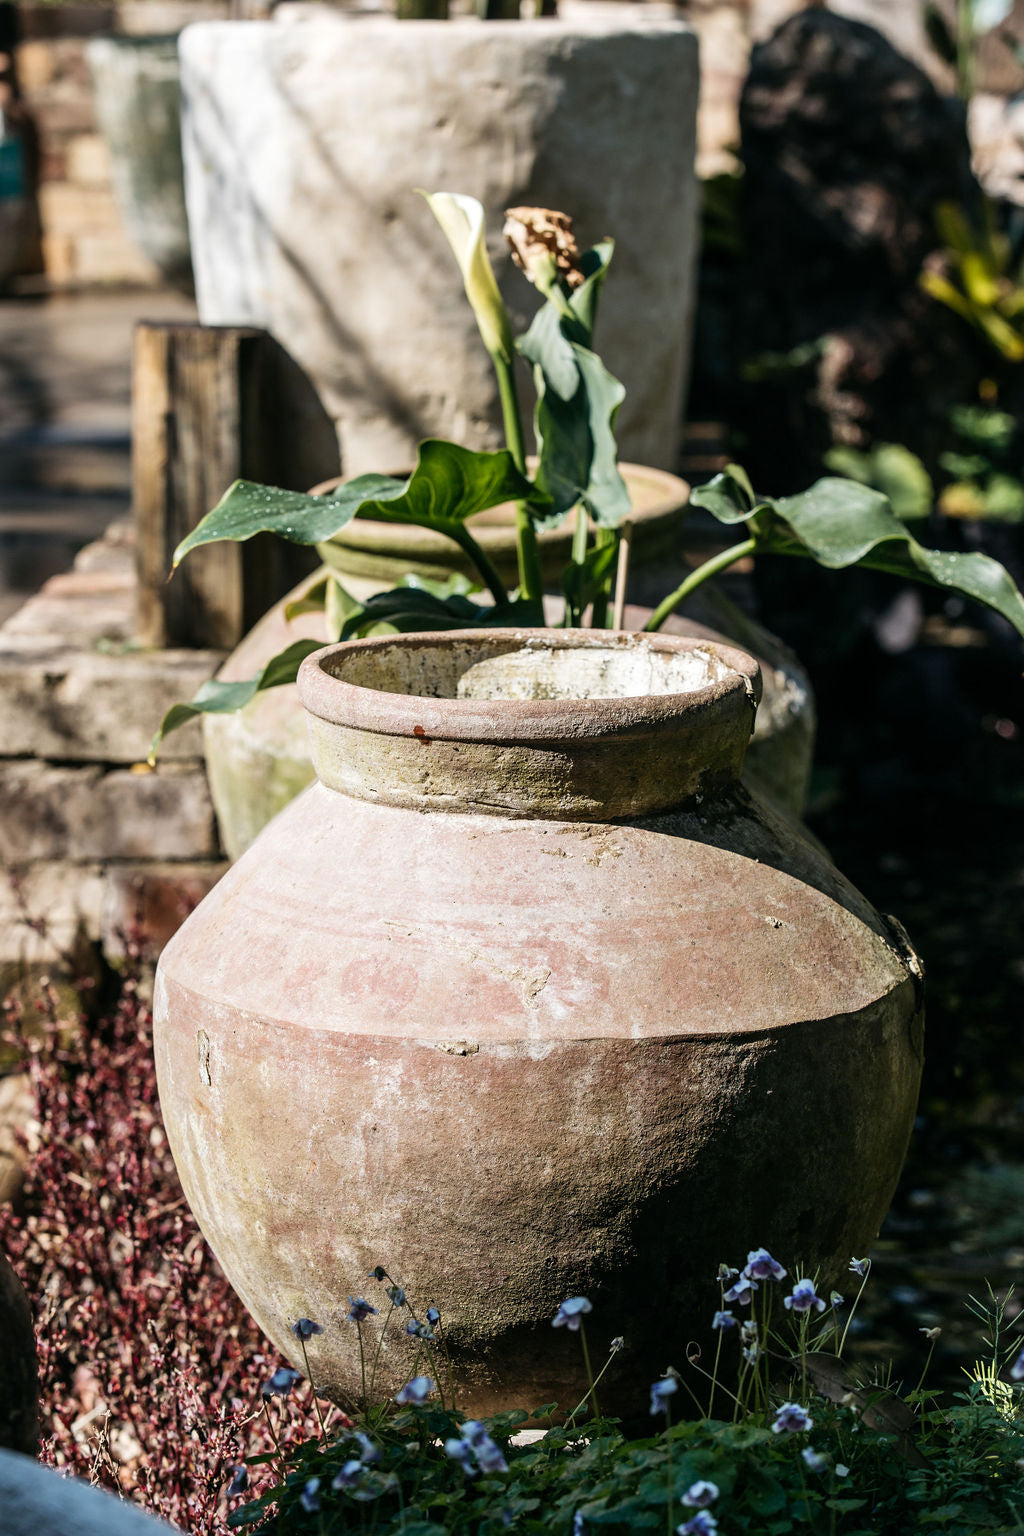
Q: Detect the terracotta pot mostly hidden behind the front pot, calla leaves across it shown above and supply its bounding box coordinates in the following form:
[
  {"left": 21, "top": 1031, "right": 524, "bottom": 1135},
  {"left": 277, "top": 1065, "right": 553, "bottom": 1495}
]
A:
[{"left": 203, "top": 464, "right": 815, "bottom": 859}]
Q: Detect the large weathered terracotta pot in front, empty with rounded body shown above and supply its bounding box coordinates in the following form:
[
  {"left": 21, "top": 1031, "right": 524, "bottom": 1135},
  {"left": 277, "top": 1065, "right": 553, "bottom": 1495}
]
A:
[{"left": 155, "top": 630, "right": 921, "bottom": 1412}]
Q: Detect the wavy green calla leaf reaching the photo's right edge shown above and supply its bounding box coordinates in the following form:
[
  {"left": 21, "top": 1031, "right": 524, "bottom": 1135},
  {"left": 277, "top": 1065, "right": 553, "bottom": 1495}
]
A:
[{"left": 691, "top": 465, "right": 1024, "bottom": 634}]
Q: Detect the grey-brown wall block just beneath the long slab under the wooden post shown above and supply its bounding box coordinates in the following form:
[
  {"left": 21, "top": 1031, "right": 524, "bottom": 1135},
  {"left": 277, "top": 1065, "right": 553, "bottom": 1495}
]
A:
[{"left": 0, "top": 759, "right": 220, "bottom": 863}]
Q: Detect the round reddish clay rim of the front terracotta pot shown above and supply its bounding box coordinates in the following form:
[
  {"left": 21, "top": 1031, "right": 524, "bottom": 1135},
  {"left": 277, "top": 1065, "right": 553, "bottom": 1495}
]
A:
[{"left": 298, "top": 627, "right": 761, "bottom": 743}]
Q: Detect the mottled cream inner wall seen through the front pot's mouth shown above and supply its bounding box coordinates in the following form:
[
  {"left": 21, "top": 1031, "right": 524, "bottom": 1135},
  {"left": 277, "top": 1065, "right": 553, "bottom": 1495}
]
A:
[{"left": 330, "top": 636, "right": 732, "bottom": 699}]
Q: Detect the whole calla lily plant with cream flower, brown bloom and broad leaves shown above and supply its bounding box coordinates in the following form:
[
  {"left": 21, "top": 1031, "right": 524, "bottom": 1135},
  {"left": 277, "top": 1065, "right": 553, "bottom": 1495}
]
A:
[{"left": 154, "top": 194, "right": 1024, "bottom": 768}]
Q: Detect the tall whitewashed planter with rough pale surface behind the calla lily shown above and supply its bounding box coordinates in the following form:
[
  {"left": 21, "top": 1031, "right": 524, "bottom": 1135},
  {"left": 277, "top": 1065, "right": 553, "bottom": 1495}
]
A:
[{"left": 180, "top": 6, "right": 699, "bottom": 475}]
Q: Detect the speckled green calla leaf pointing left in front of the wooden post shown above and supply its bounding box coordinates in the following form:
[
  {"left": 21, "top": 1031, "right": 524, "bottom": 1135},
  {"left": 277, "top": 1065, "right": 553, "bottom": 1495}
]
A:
[{"left": 173, "top": 438, "right": 536, "bottom": 565}]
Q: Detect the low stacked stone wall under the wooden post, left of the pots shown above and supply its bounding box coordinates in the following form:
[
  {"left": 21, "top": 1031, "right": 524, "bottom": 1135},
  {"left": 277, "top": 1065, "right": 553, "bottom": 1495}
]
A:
[{"left": 0, "top": 509, "right": 224, "bottom": 997}]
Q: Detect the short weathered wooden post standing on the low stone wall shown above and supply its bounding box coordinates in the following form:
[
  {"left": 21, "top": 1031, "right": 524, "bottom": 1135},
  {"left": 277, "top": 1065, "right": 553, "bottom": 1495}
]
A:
[{"left": 132, "top": 321, "right": 338, "bottom": 650}]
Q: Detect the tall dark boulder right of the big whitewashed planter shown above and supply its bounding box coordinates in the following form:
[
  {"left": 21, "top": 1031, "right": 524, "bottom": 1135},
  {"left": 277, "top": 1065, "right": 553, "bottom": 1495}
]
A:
[{"left": 737, "top": 11, "right": 981, "bottom": 490}]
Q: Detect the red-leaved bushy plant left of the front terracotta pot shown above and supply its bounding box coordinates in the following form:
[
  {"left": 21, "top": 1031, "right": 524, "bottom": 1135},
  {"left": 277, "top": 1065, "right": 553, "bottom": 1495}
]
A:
[{"left": 0, "top": 943, "right": 328, "bottom": 1536}]
